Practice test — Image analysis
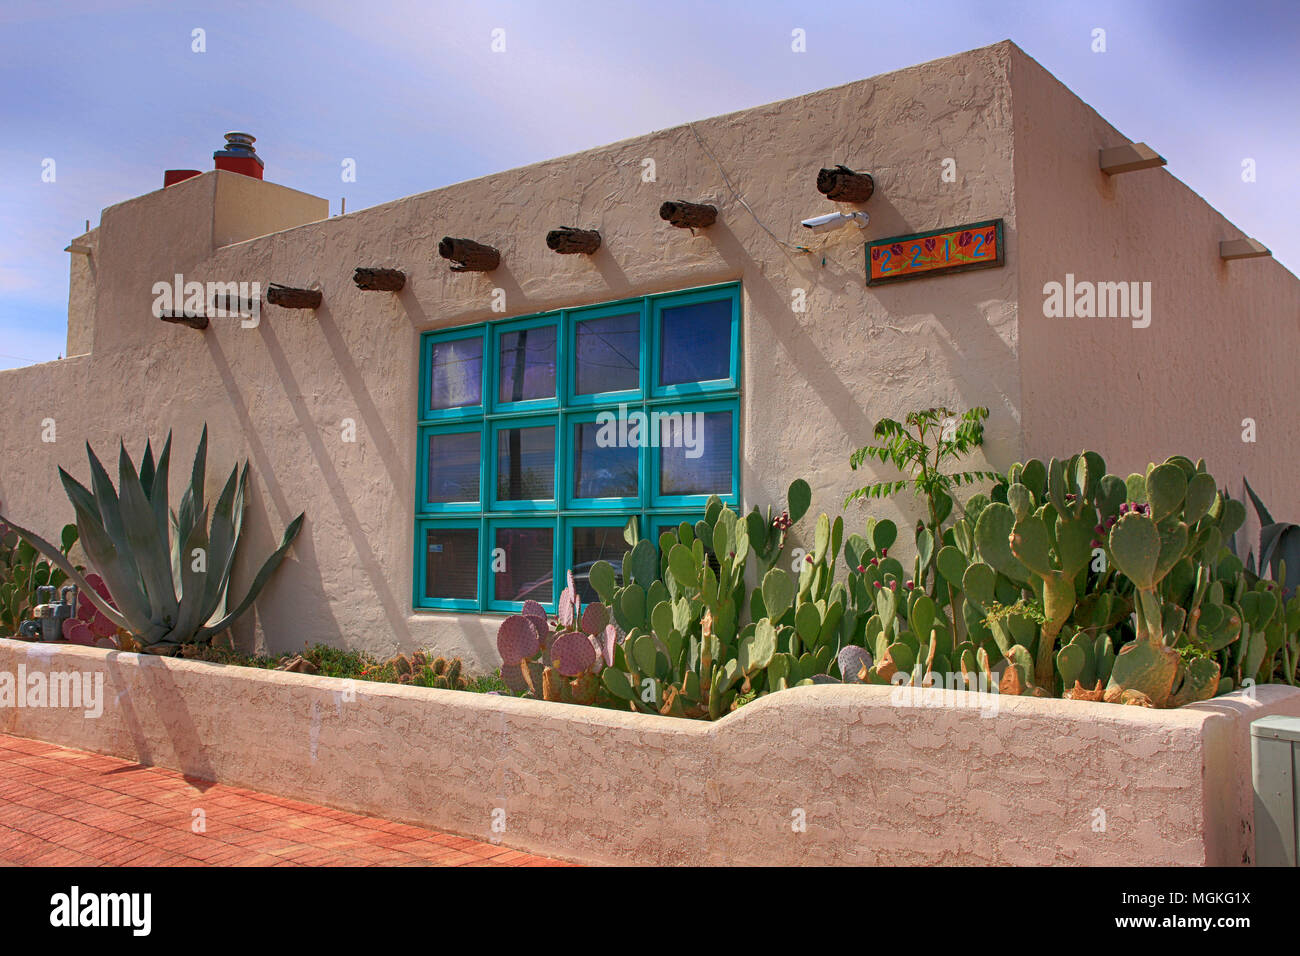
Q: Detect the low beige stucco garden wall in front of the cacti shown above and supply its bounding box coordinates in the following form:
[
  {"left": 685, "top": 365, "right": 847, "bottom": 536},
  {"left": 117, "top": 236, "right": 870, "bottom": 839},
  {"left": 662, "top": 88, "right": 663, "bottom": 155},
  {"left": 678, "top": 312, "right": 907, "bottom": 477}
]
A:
[{"left": 0, "top": 640, "right": 1300, "bottom": 865}]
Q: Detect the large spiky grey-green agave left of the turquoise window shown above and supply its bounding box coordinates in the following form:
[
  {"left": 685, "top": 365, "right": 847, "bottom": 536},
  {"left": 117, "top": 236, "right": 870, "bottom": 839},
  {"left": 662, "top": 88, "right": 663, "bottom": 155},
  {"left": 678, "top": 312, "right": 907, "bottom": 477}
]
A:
[{"left": 0, "top": 425, "right": 303, "bottom": 654}]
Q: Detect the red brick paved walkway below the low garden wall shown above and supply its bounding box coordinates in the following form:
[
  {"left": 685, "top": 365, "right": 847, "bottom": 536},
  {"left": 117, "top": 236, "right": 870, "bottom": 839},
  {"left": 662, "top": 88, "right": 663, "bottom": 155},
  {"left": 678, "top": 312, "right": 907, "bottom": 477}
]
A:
[{"left": 0, "top": 734, "right": 564, "bottom": 866}]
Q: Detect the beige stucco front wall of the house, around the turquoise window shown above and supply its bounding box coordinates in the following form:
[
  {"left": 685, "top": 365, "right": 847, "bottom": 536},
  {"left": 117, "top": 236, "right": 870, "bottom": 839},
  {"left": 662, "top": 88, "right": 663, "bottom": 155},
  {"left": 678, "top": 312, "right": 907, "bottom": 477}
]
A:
[{"left": 0, "top": 43, "right": 1021, "bottom": 666}]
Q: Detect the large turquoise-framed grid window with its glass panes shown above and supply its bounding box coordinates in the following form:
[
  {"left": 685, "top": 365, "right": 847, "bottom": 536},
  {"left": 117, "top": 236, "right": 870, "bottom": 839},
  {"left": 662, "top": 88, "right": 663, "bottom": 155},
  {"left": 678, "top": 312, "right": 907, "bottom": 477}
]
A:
[{"left": 415, "top": 284, "right": 741, "bottom": 613}]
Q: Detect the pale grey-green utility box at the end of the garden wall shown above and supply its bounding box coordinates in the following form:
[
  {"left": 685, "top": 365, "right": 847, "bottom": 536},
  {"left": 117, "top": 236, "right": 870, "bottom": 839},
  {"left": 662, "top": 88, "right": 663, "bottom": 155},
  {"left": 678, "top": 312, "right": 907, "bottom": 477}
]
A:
[{"left": 1251, "top": 717, "right": 1300, "bottom": 866}]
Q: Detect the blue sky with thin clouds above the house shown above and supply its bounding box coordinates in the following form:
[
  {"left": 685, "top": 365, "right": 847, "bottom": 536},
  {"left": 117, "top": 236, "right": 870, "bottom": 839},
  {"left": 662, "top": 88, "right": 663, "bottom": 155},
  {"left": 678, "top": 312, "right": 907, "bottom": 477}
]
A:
[{"left": 0, "top": 0, "right": 1300, "bottom": 368}]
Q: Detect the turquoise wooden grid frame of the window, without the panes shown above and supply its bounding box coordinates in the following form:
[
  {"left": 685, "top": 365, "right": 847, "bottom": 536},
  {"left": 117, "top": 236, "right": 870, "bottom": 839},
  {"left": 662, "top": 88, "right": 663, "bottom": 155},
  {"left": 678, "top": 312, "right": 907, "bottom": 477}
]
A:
[{"left": 412, "top": 282, "right": 741, "bottom": 614}]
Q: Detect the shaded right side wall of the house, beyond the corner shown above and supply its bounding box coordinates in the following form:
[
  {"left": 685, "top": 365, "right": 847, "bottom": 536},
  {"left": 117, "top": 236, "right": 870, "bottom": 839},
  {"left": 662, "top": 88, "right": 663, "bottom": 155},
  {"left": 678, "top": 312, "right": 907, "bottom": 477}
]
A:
[{"left": 1010, "top": 48, "right": 1300, "bottom": 519}]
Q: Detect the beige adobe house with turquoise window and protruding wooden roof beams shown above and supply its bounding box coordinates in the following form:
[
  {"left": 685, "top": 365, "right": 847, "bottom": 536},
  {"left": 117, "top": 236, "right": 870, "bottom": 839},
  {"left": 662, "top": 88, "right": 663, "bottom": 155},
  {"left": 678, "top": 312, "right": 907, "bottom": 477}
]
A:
[{"left": 0, "top": 42, "right": 1300, "bottom": 667}]
